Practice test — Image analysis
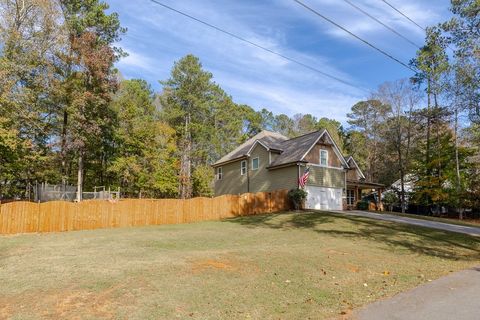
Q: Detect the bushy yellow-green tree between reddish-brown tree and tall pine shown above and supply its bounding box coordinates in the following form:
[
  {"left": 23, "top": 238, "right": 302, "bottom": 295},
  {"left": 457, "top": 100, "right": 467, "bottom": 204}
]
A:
[{"left": 108, "top": 80, "right": 178, "bottom": 197}]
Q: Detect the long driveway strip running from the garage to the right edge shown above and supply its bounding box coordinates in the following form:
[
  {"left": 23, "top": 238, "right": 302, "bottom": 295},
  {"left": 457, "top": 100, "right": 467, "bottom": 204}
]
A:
[{"left": 335, "top": 210, "right": 480, "bottom": 236}]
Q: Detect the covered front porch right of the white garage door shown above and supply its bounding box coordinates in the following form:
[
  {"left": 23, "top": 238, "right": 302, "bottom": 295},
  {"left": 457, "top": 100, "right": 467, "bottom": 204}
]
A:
[{"left": 343, "top": 180, "right": 385, "bottom": 211}]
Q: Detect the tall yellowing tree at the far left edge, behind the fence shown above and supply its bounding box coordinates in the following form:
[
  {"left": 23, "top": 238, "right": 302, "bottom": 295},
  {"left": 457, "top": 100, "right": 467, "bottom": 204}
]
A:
[{"left": 0, "top": 0, "right": 61, "bottom": 196}]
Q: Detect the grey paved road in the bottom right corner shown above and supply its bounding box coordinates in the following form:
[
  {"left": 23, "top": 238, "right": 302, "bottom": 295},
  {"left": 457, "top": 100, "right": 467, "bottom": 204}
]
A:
[{"left": 352, "top": 267, "right": 480, "bottom": 320}]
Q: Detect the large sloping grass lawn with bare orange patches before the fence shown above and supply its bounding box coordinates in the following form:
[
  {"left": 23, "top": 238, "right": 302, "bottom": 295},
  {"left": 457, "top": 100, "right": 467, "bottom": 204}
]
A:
[{"left": 0, "top": 213, "right": 480, "bottom": 319}]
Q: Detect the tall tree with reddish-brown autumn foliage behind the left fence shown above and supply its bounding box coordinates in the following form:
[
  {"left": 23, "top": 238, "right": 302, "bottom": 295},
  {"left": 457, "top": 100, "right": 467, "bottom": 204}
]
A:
[{"left": 56, "top": 0, "right": 125, "bottom": 201}]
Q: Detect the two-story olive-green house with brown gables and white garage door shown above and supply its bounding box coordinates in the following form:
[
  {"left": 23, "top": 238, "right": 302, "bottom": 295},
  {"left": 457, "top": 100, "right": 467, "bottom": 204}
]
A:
[{"left": 213, "top": 130, "right": 383, "bottom": 210}]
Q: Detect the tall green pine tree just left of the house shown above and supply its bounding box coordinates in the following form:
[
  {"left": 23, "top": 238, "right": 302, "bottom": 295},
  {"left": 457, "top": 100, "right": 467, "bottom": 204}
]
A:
[{"left": 161, "top": 55, "right": 248, "bottom": 199}]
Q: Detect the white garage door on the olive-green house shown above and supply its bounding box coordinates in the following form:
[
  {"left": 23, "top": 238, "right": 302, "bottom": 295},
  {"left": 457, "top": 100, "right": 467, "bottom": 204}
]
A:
[{"left": 305, "top": 186, "right": 343, "bottom": 210}]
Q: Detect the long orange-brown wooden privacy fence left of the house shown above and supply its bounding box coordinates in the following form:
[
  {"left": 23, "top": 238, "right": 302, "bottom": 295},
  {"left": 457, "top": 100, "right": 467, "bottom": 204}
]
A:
[{"left": 0, "top": 190, "right": 289, "bottom": 234}]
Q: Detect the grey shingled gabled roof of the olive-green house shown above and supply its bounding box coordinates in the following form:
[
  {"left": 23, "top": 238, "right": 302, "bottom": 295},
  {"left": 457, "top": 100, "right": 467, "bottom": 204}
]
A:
[{"left": 213, "top": 129, "right": 348, "bottom": 168}]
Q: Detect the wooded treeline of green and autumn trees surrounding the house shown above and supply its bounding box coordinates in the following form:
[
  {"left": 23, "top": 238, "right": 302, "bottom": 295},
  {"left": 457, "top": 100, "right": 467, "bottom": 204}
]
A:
[{"left": 0, "top": 0, "right": 480, "bottom": 215}]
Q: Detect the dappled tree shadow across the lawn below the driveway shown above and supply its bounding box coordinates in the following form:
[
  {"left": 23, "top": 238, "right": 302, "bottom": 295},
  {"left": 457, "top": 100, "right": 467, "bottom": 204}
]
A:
[{"left": 225, "top": 211, "right": 480, "bottom": 263}]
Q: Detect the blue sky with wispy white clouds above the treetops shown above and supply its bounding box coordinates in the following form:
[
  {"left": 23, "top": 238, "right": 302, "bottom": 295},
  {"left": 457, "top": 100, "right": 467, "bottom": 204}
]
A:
[{"left": 108, "top": 0, "right": 450, "bottom": 122}]
